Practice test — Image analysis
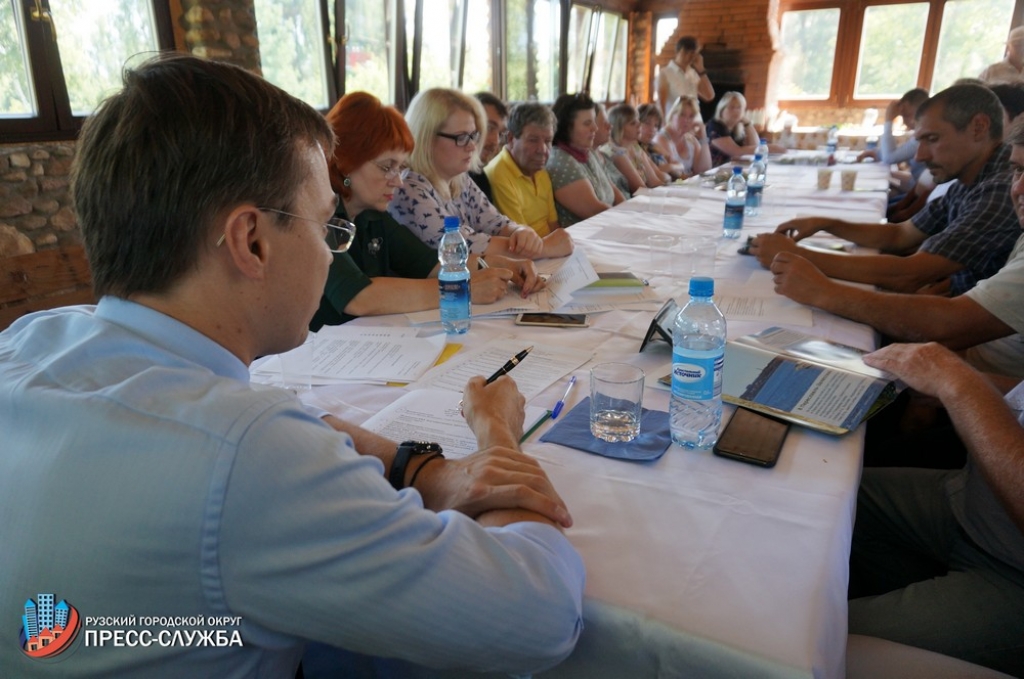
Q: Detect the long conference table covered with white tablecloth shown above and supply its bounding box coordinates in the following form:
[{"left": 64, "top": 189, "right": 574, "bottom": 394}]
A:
[{"left": 301, "top": 157, "right": 889, "bottom": 679}]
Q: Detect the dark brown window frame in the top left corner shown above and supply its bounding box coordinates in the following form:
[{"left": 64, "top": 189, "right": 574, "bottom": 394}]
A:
[{"left": 0, "top": 0, "right": 175, "bottom": 143}]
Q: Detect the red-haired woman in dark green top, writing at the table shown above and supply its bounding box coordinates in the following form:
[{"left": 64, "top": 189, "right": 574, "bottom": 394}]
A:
[{"left": 309, "top": 92, "right": 544, "bottom": 331}]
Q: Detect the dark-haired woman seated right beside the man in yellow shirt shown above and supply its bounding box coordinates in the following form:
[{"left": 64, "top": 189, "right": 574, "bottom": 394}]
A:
[{"left": 547, "top": 93, "right": 625, "bottom": 226}]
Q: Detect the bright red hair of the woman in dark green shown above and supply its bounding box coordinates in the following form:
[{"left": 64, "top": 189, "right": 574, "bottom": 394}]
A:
[{"left": 327, "top": 92, "right": 414, "bottom": 198}]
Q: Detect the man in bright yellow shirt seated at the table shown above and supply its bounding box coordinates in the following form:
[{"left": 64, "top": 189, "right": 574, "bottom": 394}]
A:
[{"left": 483, "top": 101, "right": 558, "bottom": 237}]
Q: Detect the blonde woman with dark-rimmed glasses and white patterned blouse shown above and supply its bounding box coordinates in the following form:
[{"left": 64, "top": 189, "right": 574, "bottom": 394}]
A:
[{"left": 388, "top": 88, "right": 572, "bottom": 259}]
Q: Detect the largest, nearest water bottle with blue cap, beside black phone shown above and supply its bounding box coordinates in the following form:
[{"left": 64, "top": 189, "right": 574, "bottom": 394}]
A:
[{"left": 669, "top": 277, "right": 725, "bottom": 450}]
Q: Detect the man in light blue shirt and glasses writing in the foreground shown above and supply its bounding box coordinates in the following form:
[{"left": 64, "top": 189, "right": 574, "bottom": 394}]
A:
[{"left": 0, "top": 55, "right": 584, "bottom": 679}]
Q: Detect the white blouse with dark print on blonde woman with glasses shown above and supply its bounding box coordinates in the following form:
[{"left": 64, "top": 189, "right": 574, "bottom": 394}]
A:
[{"left": 387, "top": 172, "right": 519, "bottom": 254}]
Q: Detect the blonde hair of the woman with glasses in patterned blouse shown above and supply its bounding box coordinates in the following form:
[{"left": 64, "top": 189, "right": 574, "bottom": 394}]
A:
[{"left": 406, "top": 87, "right": 487, "bottom": 200}]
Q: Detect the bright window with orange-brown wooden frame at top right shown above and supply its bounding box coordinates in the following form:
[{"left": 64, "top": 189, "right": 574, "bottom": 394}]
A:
[{"left": 777, "top": 0, "right": 1024, "bottom": 108}]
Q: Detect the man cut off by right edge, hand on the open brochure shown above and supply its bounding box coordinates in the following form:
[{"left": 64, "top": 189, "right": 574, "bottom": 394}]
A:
[{"left": 849, "top": 344, "right": 1024, "bottom": 677}]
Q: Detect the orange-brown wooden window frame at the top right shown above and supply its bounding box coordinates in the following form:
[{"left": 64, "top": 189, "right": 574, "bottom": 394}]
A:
[{"left": 776, "top": 0, "right": 1024, "bottom": 111}]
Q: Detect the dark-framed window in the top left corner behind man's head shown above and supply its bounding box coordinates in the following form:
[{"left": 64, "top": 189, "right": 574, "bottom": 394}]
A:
[{"left": 0, "top": 0, "right": 172, "bottom": 140}]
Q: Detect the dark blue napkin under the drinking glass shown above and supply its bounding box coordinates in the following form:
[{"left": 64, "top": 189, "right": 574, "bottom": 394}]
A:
[{"left": 541, "top": 396, "right": 672, "bottom": 461}]
